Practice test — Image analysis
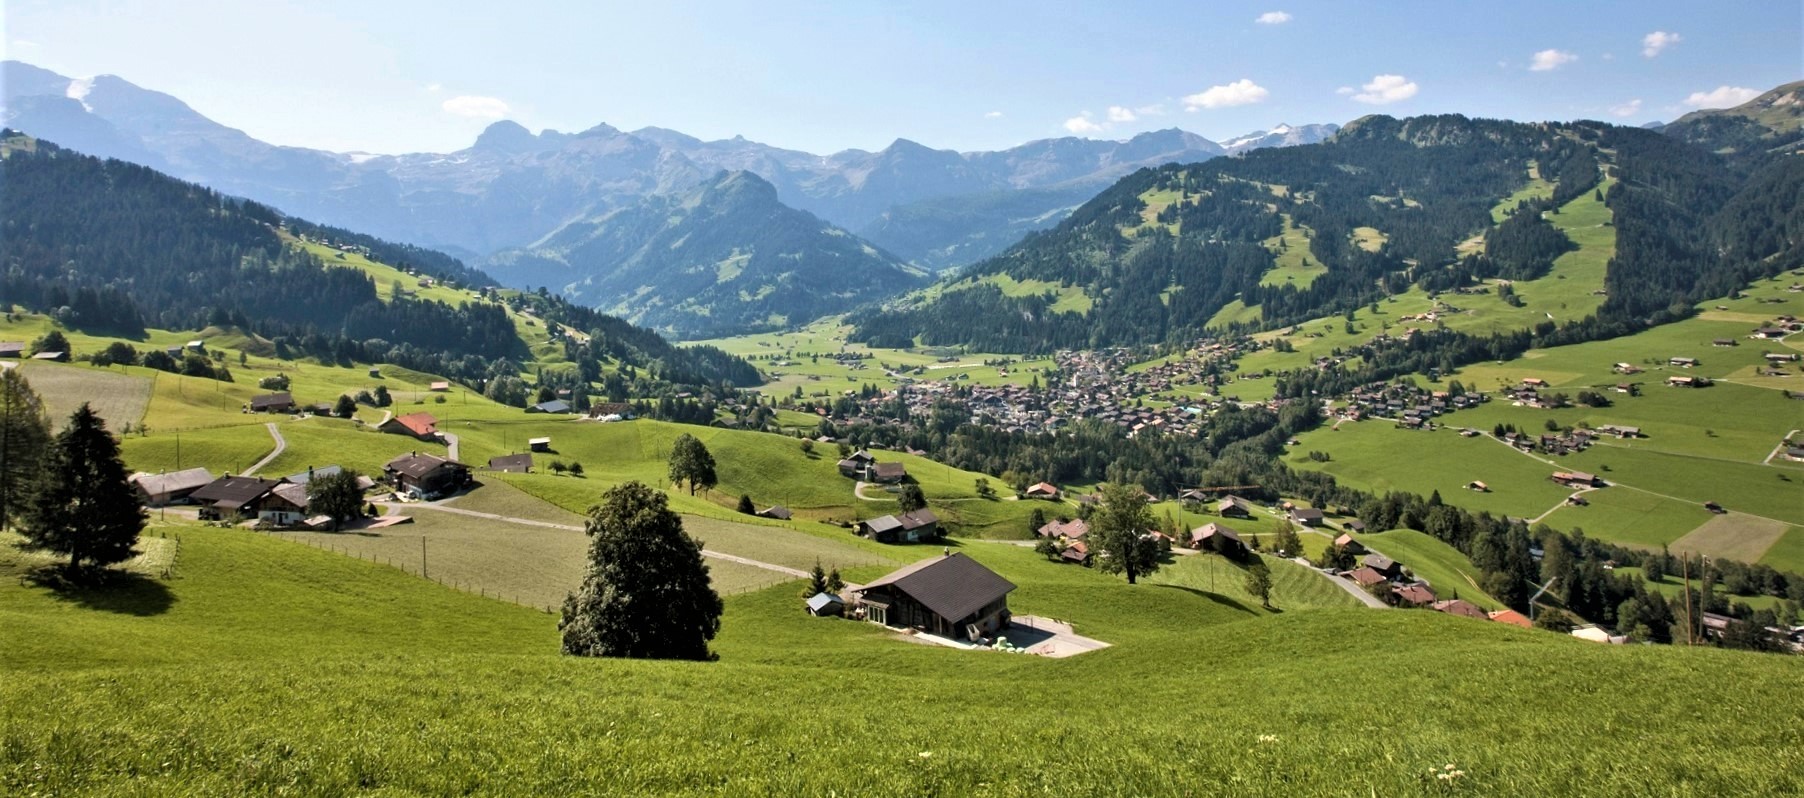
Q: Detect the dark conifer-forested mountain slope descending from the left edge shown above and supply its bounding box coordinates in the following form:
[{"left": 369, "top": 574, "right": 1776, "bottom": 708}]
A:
[{"left": 0, "top": 130, "right": 758, "bottom": 383}]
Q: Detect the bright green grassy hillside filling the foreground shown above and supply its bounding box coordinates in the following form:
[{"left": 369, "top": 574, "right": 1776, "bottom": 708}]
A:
[{"left": 0, "top": 529, "right": 1804, "bottom": 794}]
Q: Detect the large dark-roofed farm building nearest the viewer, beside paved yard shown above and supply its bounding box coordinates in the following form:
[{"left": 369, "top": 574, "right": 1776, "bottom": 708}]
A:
[{"left": 859, "top": 554, "right": 1016, "bottom": 641}]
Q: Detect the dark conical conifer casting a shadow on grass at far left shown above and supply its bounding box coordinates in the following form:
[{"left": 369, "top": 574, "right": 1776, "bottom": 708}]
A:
[{"left": 23, "top": 403, "right": 144, "bottom": 569}]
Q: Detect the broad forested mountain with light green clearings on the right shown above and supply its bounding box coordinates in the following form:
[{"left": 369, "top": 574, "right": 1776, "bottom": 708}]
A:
[{"left": 855, "top": 116, "right": 1799, "bottom": 352}]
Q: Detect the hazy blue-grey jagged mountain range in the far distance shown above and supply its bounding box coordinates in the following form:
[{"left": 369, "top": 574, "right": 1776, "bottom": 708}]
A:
[{"left": 0, "top": 61, "right": 1337, "bottom": 332}]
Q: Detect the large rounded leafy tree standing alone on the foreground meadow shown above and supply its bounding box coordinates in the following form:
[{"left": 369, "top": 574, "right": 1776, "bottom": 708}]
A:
[{"left": 557, "top": 482, "right": 722, "bottom": 659}]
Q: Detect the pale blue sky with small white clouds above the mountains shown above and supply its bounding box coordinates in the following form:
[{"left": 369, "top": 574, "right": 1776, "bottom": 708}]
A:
[{"left": 0, "top": 0, "right": 1804, "bottom": 153}]
